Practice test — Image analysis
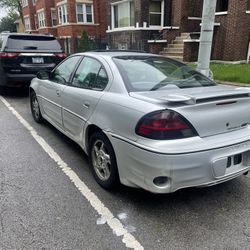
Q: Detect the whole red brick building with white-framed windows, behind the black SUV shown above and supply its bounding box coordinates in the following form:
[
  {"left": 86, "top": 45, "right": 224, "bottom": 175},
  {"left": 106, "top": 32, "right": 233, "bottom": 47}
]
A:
[{"left": 22, "top": 0, "right": 107, "bottom": 53}]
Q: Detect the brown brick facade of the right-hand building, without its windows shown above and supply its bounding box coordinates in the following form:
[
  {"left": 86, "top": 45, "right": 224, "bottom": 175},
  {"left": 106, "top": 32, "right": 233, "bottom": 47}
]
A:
[{"left": 107, "top": 0, "right": 250, "bottom": 61}]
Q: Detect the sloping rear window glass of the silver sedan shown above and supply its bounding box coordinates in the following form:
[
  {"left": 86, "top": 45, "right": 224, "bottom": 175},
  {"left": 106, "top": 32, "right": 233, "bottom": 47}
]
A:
[{"left": 113, "top": 56, "right": 215, "bottom": 92}]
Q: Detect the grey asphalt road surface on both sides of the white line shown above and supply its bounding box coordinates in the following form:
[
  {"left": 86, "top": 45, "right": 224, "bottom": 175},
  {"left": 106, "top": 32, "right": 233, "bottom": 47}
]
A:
[{"left": 0, "top": 90, "right": 250, "bottom": 250}]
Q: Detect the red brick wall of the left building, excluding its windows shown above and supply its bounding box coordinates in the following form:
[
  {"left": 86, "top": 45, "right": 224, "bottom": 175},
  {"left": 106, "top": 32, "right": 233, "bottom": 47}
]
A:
[{"left": 23, "top": 0, "right": 107, "bottom": 52}]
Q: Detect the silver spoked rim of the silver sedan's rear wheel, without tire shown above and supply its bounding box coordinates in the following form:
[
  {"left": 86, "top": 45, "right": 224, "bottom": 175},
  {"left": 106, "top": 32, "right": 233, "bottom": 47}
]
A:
[{"left": 91, "top": 140, "right": 111, "bottom": 181}]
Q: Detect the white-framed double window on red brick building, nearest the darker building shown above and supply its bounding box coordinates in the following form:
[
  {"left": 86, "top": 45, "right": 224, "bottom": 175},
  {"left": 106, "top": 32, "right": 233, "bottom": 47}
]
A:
[{"left": 76, "top": 3, "right": 94, "bottom": 23}]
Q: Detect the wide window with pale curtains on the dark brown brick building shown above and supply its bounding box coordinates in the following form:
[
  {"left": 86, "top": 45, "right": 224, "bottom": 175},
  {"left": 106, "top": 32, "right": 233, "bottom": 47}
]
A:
[{"left": 111, "top": 1, "right": 135, "bottom": 28}]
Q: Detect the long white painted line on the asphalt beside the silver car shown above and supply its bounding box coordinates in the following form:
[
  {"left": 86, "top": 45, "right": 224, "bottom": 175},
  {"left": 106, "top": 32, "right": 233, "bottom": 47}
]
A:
[{"left": 0, "top": 96, "right": 144, "bottom": 250}]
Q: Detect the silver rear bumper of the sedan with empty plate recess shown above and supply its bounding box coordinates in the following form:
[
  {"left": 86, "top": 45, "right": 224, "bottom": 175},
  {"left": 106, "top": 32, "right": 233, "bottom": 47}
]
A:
[{"left": 110, "top": 136, "right": 250, "bottom": 193}]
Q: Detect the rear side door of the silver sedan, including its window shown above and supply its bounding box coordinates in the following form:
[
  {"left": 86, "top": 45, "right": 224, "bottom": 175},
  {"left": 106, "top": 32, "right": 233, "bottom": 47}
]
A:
[{"left": 62, "top": 57, "right": 108, "bottom": 142}]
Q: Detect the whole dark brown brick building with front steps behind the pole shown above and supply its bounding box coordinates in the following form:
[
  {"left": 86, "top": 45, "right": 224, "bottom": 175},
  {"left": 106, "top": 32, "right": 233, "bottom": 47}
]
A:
[{"left": 106, "top": 0, "right": 250, "bottom": 61}]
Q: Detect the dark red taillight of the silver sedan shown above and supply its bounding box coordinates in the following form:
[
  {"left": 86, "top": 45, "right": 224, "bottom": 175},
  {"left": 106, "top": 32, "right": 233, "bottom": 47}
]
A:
[{"left": 136, "top": 110, "right": 197, "bottom": 140}]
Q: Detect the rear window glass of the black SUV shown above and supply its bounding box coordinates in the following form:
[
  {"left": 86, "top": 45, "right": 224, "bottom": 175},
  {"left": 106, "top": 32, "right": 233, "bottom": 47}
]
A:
[{"left": 6, "top": 35, "right": 61, "bottom": 51}]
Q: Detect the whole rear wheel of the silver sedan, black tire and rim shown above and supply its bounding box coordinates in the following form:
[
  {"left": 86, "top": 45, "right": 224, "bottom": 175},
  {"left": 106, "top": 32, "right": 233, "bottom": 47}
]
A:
[{"left": 89, "top": 132, "right": 120, "bottom": 189}]
